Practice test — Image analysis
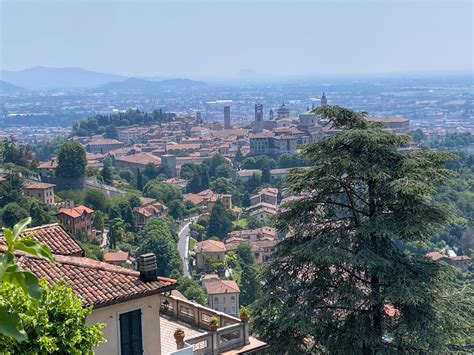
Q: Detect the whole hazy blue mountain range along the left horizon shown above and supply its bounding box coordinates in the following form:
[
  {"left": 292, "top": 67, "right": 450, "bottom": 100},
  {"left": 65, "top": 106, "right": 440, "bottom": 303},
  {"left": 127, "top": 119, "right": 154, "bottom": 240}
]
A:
[{"left": 0, "top": 67, "right": 207, "bottom": 94}]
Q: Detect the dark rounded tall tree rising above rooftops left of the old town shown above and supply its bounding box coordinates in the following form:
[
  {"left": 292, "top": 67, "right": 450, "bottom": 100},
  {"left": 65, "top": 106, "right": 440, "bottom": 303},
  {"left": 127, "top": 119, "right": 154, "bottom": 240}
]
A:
[{"left": 56, "top": 142, "right": 87, "bottom": 178}]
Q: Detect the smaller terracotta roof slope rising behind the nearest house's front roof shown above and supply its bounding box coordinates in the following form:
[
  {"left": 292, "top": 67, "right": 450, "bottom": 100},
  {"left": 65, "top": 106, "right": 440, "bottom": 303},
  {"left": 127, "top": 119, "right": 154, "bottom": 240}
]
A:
[{"left": 0, "top": 223, "right": 84, "bottom": 256}]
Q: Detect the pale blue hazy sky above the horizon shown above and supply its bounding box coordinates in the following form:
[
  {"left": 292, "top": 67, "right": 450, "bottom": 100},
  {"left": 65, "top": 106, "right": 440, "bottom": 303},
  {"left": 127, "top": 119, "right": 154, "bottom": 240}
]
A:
[{"left": 0, "top": 0, "right": 473, "bottom": 77}]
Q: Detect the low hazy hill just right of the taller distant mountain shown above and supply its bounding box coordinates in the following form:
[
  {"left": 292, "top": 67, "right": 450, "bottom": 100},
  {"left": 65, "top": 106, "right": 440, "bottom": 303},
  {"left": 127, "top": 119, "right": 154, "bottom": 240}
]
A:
[{"left": 97, "top": 78, "right": 207, "bottom": 94}]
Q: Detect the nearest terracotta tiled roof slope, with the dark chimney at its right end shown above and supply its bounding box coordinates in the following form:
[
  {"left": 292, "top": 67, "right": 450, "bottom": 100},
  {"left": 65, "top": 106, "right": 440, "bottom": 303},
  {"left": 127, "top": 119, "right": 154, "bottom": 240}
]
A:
[{"left": 17, "top": 255, "right": 176, "bottom": 307}]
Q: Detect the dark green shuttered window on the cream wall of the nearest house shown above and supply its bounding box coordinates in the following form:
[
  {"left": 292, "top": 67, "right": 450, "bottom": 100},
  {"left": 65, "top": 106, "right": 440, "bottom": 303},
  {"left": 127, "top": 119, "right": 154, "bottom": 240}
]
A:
[{"left": 120, "top": 309, "right": 143, "bottom": 355}]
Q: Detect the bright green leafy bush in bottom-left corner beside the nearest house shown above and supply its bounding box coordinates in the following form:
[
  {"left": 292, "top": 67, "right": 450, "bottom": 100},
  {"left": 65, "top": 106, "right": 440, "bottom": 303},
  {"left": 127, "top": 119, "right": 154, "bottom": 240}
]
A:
[{"left": 0, "top": 282, "right": 105, "bottom": 354}]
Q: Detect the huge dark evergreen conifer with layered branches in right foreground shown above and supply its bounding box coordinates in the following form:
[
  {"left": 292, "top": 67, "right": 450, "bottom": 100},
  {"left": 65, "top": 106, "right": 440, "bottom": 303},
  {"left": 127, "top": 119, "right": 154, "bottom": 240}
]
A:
[{"left": 254, "top": 106, "right": 474, "bottom": 354}]
